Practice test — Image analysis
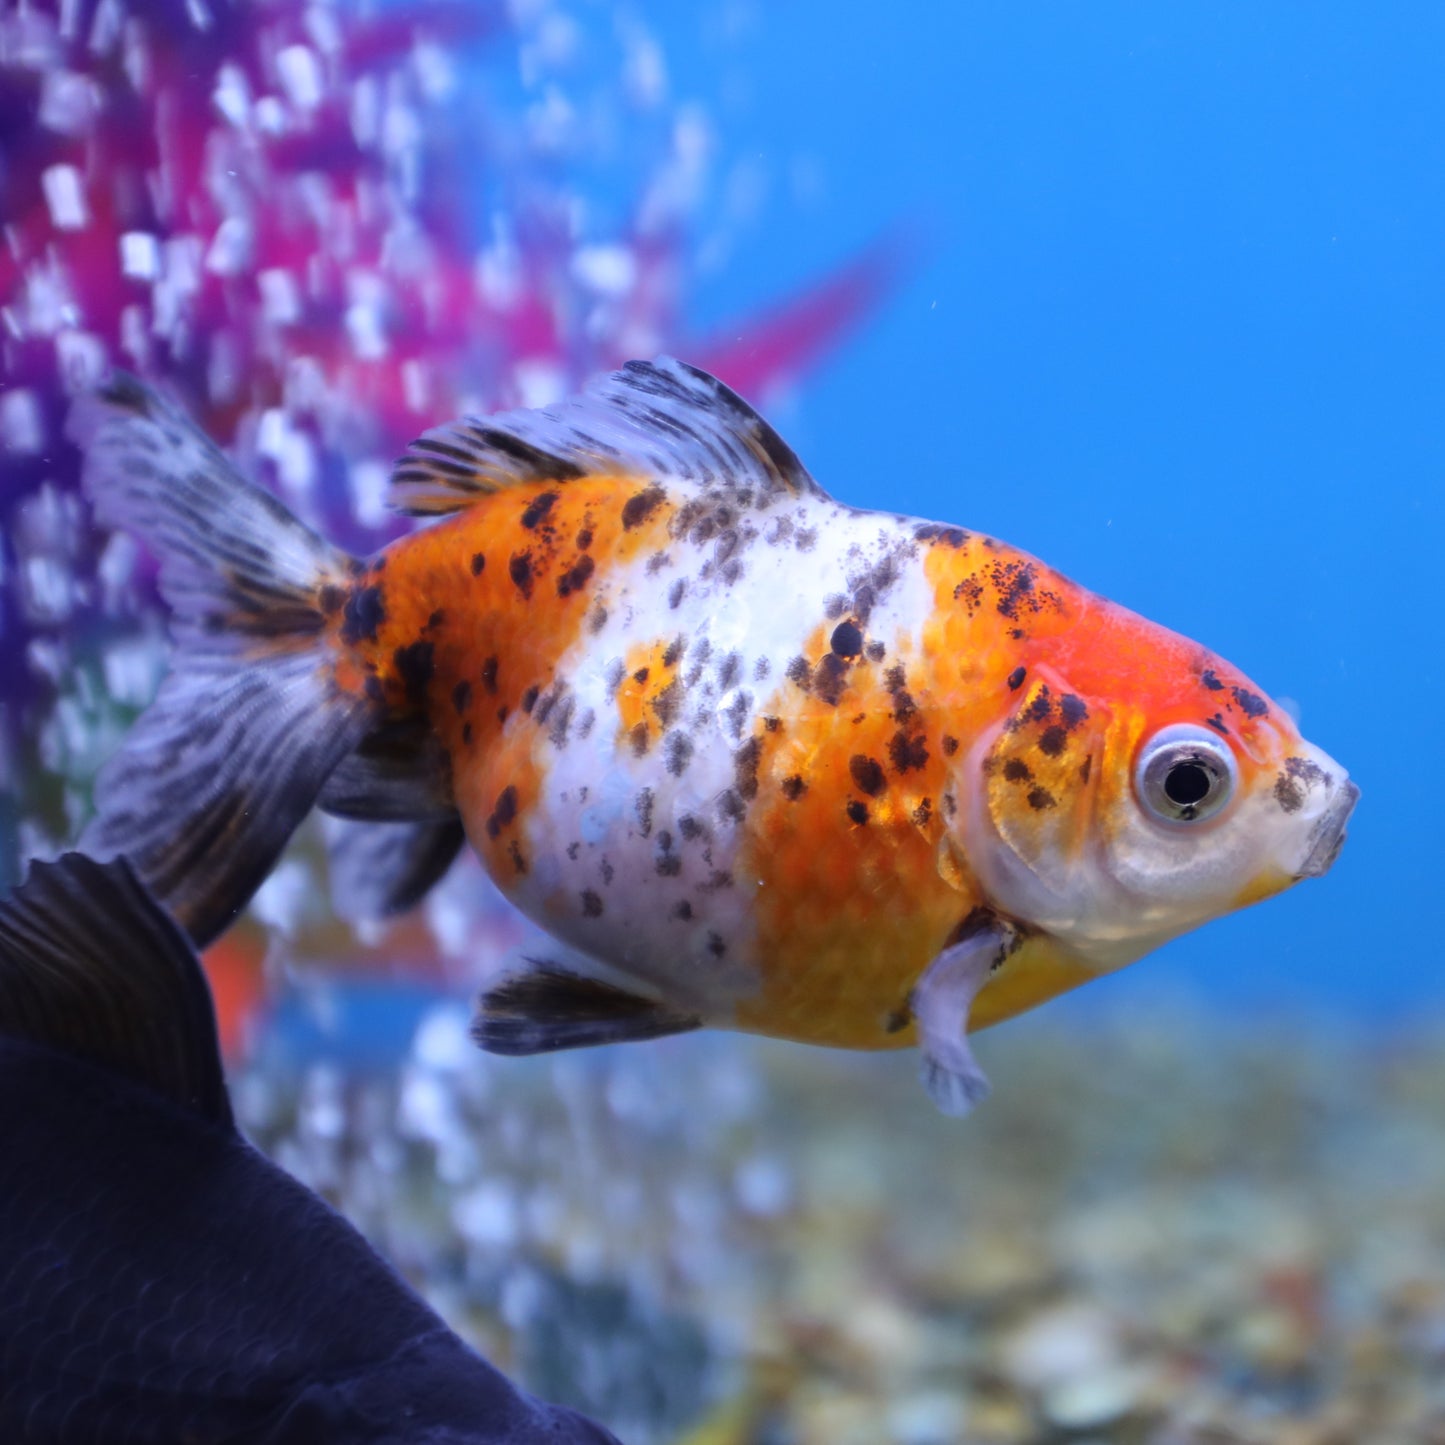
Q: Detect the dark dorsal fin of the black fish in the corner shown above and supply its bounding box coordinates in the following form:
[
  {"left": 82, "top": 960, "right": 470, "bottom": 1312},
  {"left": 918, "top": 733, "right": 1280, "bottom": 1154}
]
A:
[{"left": 0, "top": 853, "right": 231, "bottom": 1126}]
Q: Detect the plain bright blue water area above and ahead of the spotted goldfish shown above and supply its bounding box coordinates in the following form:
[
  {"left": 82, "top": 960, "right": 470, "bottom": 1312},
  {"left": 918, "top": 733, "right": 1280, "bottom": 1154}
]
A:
[{"left": 646, "top": 0, "right": 1445, "bottom": 1019}]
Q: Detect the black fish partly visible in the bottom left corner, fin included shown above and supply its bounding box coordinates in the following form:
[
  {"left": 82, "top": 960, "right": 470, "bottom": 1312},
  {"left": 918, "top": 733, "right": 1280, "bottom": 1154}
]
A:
[{"left": 0, "top": 853, "right": 616, "bottom": 1445}]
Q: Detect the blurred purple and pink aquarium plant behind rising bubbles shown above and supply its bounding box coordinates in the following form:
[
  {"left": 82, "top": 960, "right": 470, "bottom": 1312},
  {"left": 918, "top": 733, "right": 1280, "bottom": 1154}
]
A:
[{"left": 0, "top": 0, "right": 892, "bottom": 877}]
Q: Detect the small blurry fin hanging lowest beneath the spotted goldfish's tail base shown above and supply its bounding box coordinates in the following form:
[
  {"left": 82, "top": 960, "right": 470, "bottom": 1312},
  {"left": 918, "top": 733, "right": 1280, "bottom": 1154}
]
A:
[{"left": 327, "top": 814, "right": 467, "bottom": 919}]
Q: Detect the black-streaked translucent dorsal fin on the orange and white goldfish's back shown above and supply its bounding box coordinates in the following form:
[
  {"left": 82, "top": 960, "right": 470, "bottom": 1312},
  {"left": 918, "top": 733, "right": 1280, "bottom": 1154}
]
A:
[{"left": 390, "top": 357, "right": 825, "bottom": 516}]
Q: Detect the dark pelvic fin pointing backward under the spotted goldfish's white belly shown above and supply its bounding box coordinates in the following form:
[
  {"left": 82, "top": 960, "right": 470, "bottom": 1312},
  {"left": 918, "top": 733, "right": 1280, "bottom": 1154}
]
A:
[{"left": 471, "top": 959, "right": 702, "bottom": 1055}]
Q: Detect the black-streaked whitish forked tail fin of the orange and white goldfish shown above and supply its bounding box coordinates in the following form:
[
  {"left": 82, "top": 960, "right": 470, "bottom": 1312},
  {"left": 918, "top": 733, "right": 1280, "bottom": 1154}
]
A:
[{"left": 69, "top": 374, "right": 379, "bottom": 945}]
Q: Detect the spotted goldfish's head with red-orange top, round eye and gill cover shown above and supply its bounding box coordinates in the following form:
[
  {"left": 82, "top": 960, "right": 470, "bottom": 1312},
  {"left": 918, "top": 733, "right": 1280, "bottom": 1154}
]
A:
[{"left": 954, "top": 603, "right": 1358, "bottom": 972}]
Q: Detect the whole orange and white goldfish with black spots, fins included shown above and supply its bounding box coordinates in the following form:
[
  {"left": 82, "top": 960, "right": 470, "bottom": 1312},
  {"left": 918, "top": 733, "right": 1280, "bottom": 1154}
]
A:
[{"left": 77, "top": 361, "right": 1358, "bottom": 1113}]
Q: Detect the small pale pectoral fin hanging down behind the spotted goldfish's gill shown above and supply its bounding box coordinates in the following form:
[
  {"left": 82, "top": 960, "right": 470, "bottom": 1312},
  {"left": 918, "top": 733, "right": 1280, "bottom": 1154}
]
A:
[{"left": 912, "top": 912, "right": 1020, "bottom": 1117}]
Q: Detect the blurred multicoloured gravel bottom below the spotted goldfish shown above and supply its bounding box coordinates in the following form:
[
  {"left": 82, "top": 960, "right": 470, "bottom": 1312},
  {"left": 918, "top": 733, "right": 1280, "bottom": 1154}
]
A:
[{"left": 237, "top": 1004, "right": 1445, "bottom": 1445}]
